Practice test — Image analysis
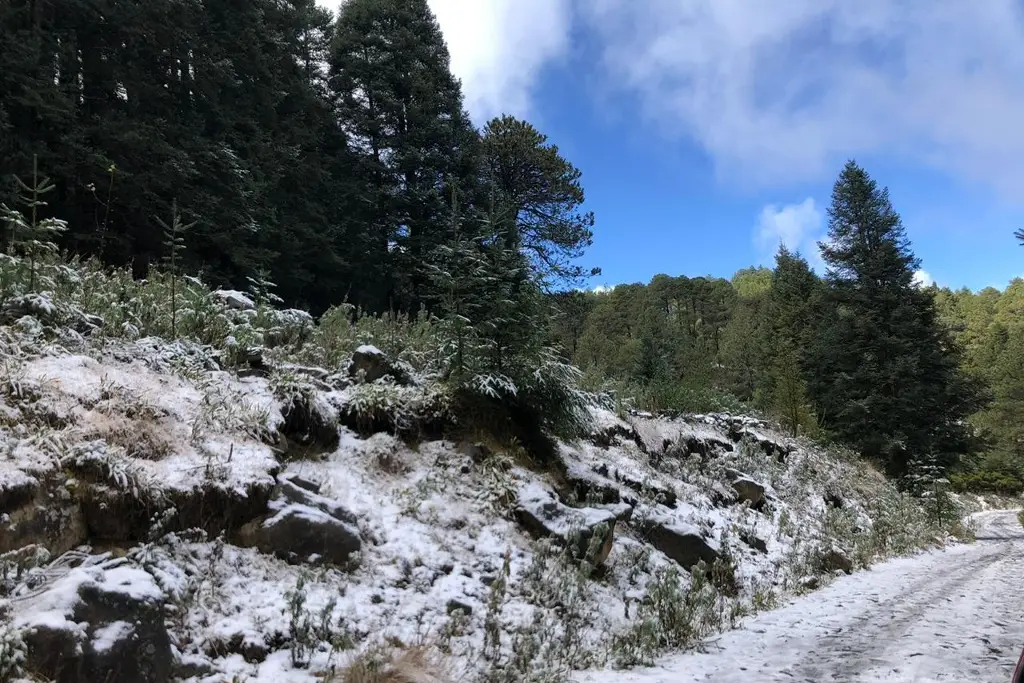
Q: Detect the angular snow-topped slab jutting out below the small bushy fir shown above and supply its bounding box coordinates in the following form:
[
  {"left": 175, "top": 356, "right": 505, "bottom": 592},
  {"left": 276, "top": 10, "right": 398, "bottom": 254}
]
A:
[{"left": 515, "top": 483, "right": 615, "bottom": 564}]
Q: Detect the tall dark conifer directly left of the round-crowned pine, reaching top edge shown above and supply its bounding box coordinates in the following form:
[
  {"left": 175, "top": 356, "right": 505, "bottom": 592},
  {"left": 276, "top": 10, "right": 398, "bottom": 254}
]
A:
[{"left": 330, "top": 0, "right": 479, "bottom": 310}]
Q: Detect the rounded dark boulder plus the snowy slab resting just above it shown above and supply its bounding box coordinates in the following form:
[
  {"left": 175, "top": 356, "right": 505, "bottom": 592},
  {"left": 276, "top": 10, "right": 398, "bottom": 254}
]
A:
[{"left": 238, "top": 474, "right": 362, "bottom": 567}]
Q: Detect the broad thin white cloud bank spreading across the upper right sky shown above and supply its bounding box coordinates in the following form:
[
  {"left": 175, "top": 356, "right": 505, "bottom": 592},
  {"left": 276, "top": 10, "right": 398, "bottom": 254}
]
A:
[{"left": 579, "top": 0, "right": 1024, "bottom": 200}]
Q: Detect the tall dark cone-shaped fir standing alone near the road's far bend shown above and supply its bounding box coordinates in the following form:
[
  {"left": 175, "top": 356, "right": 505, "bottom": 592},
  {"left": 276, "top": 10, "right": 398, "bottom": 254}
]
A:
[{"left": 811, "top": 162, "right": 982, "bottom": 474}]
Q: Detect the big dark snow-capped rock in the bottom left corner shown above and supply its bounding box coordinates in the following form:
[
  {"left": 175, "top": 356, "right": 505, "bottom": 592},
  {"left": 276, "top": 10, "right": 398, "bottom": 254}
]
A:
[{"left": 14, "top": 560, "right": 174, "bottom": 683}]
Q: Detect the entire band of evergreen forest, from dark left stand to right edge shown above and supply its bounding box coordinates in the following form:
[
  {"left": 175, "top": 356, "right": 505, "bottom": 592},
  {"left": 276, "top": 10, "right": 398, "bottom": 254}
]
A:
[{"left": 0, "top": 0, "right": 1022, "bottom": 490}]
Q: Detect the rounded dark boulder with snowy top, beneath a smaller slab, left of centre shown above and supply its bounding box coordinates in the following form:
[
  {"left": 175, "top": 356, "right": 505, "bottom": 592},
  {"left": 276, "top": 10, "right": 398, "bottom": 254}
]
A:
[{"left": 239, "top": 503, "right": 362, "bottom": 567}]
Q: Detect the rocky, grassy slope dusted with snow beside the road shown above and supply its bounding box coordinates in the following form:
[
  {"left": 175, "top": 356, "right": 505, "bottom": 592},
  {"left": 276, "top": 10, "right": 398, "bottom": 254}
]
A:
[{"left": 0, "top": 252, "right": 970, "bottom": 682}]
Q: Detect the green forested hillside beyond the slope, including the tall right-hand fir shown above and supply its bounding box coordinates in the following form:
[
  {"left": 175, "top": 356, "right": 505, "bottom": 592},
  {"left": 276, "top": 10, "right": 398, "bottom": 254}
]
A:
[{"left": 553, "top": 162, "right": 999, "bottom": 485}]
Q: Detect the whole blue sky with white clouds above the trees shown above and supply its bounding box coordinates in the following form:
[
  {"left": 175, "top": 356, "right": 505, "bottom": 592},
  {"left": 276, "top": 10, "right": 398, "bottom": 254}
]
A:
[{"left": 325, "top": 0, "right": 1024, "bottom": 290}]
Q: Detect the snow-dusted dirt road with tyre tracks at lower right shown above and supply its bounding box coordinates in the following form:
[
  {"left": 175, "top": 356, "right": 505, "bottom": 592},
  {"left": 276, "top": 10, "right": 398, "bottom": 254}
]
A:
[{"left": 579, "top": 512, "right": 1024, "bottom": 683}]
